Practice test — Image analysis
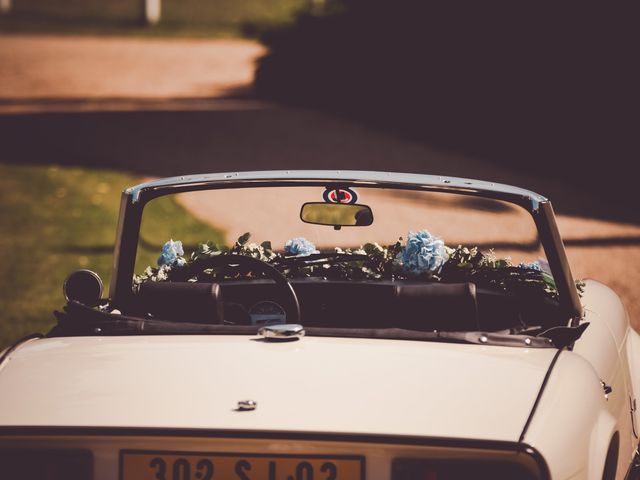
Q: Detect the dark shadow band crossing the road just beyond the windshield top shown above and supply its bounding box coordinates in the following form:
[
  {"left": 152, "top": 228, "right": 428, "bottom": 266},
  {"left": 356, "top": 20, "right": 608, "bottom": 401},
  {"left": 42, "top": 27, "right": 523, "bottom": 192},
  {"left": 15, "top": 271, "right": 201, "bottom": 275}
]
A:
[{"left": 0, "top": 99, "right": 640, "bottom": 227}]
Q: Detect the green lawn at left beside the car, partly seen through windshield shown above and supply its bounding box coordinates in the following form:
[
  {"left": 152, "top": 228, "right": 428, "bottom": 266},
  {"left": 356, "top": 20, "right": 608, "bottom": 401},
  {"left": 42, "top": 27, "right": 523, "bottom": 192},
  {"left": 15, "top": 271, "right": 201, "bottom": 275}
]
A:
[{"left": 0, "top": 165, "right": 222, "bottom": 349}]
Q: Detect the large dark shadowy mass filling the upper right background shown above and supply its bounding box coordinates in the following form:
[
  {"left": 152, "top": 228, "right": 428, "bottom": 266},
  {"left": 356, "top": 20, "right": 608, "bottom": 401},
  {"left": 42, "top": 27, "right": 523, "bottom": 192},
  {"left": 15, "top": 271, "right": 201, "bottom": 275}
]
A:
[{"left": 255, "top": 0, "right": 640, "bottom": 225}]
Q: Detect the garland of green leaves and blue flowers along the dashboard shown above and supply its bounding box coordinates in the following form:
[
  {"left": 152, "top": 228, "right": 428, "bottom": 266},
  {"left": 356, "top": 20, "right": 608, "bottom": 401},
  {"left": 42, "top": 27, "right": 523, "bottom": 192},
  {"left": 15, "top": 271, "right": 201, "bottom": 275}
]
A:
[{"left": 134, "top": 230, "right": 584, "bottom": 300}]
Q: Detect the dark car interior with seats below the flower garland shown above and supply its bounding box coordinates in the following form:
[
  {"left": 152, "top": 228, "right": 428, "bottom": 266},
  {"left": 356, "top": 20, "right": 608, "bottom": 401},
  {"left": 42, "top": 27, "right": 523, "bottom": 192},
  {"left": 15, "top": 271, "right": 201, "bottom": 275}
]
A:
[{"left": 135, "top": 278, "right": 562, "bottom": 331}]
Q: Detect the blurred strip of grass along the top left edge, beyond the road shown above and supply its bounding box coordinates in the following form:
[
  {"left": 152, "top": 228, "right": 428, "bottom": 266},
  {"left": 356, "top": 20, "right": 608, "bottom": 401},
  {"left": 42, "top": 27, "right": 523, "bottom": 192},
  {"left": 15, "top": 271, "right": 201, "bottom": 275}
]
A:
[{"left": 0, "top": 0, "right": 308, "bottom": 37}]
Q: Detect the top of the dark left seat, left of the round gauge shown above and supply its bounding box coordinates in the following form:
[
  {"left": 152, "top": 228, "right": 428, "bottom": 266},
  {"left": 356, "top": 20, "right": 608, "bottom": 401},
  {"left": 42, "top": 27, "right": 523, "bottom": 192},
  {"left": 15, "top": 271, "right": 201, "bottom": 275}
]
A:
[{"left": 137, "top": 282, "right": 223, "bottom": 324}]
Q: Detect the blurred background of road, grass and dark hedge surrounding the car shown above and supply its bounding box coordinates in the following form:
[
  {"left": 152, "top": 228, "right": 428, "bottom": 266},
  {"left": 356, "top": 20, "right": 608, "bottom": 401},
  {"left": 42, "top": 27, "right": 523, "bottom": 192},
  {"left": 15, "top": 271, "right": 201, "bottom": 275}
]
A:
[{"left": 0, "top": 0, "right": 640, "bottom": 346}]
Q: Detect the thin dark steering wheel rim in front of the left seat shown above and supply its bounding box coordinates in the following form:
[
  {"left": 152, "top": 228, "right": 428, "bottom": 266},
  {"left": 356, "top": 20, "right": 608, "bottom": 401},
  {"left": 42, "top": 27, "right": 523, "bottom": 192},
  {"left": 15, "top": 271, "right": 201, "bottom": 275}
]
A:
[{"left": 178, "top": 254, "right": 300, "bottom": 323}]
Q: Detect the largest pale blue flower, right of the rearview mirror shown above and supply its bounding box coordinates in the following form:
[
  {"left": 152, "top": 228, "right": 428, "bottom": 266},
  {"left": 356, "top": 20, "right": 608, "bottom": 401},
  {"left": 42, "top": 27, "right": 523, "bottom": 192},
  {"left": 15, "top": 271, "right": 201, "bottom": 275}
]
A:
[{"left": 397, "top": 230, "right": 449, "bottom": 275}]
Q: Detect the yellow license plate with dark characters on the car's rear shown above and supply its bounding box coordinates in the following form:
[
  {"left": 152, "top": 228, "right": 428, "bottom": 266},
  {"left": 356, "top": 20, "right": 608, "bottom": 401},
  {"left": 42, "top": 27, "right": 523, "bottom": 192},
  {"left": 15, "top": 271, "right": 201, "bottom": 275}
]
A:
[{"left": 120, "top": 450, "right": 364, "bottom": 480}]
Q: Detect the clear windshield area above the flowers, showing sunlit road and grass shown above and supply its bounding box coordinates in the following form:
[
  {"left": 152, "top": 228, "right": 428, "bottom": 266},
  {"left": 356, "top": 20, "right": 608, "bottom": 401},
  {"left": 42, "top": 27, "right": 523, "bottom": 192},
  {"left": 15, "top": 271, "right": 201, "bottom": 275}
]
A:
[{"left": 136, "top": 187, "right": 546, "bottom": 282}]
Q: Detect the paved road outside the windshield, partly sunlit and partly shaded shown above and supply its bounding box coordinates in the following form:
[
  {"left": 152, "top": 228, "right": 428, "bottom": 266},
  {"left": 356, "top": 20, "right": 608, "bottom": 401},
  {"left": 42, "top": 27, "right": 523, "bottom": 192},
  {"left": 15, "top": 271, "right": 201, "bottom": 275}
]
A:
[{"left": 0, "top": 32, "right": 640, "bottom": 327}]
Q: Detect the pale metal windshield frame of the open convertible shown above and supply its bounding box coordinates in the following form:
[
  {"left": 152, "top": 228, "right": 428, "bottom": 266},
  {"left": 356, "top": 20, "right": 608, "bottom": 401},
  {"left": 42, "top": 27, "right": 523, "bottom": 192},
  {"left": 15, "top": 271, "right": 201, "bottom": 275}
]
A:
[{"left": 109, "top": 170, "right": 582, "bottom": 325}]
